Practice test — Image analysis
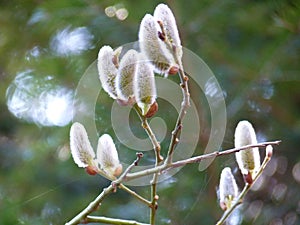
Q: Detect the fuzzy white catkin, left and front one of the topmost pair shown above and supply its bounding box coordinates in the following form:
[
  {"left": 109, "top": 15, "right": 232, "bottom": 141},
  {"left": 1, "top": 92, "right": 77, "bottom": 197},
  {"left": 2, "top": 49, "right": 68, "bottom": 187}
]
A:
[{"left": 139, "top": 14, "right": 176, "bottom": 76}]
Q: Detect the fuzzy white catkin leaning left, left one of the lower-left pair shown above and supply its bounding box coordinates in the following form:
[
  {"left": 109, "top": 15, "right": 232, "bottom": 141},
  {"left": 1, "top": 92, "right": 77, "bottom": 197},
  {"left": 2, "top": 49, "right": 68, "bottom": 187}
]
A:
[{"left": 70, "top": 122, "right": 95, "bottom": 167}]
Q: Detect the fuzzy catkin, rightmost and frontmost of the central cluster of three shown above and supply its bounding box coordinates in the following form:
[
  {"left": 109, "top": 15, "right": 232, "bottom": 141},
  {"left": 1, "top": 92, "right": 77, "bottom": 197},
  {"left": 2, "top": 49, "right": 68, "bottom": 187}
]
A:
[{"left": 134, "top": 54, "right": 157, "bottom": 116}]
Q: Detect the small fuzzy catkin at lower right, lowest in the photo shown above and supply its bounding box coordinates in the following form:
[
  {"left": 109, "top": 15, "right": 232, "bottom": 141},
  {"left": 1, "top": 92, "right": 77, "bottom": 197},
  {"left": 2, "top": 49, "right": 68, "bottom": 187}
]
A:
[{"left": 219, "top": 167, "right": 238, "bottom": 211}]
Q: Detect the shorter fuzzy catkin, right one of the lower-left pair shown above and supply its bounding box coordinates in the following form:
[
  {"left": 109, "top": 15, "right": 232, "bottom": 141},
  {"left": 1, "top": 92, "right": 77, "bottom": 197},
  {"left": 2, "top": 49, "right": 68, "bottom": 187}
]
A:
[{"left": 97, "top": 134, "right": 122, "bottom": 176}]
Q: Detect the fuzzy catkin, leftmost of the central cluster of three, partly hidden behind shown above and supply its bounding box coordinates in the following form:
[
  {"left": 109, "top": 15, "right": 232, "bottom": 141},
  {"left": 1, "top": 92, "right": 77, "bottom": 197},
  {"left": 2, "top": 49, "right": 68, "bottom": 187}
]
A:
[{"left": 98, "top": 46, "right": 121, "bottom": 99}]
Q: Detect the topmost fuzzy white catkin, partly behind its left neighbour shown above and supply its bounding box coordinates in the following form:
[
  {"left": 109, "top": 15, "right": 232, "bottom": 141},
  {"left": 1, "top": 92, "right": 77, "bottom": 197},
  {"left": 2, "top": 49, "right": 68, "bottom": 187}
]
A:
[{"left": 153, "top": 4, "right": 182, "bottom": 60}]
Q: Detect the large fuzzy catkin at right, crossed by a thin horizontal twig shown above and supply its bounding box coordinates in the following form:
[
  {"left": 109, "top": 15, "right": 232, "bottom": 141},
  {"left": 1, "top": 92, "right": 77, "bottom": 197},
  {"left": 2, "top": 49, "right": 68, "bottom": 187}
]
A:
[{"left": 234, "top": 120, "right": 260, "bottom": 178}]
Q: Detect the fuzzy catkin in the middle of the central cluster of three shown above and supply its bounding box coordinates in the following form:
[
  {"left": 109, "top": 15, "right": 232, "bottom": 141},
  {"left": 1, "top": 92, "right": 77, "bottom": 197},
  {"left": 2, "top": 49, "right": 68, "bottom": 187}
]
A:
[{"left": 116, "top": 49, "right": 138, "bottom": 101}]
